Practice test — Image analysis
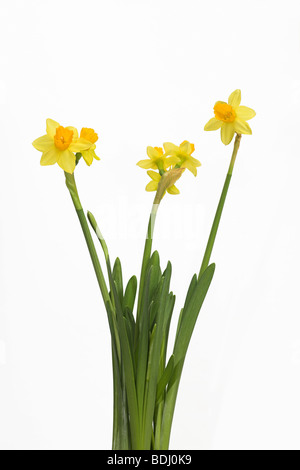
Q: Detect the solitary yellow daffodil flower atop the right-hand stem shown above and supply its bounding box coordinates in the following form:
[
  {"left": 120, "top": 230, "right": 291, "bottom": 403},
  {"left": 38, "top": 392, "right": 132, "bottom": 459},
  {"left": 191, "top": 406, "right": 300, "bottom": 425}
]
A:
[{"left": 204, "top": 90, "right": 256, "bottom": 145}]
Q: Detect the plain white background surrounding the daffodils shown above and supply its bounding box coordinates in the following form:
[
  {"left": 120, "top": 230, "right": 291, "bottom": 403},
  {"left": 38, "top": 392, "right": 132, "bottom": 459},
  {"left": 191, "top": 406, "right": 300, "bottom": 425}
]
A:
[{"left": 0, "top": 0, "right": 300, "bottom": 449}]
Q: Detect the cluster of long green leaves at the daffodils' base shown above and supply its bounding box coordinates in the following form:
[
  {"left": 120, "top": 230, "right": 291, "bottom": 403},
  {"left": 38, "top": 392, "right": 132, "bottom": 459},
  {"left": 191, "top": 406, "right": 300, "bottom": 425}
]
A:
[{"left": 88, "top": 213, "right": 215, "bottom": 450}]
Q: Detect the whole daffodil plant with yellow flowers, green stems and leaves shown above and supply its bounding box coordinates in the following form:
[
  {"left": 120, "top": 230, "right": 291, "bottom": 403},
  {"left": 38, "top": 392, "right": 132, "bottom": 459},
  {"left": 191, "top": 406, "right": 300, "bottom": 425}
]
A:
[{"left": 33, "top": 90, "right": 255, "bottom": 450}]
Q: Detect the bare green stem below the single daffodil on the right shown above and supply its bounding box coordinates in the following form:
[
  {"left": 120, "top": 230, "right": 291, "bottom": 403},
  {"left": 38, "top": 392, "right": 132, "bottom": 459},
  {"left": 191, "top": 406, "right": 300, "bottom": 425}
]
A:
[{"left": 199, "top": 134, "right": 241, "bottom": 277}]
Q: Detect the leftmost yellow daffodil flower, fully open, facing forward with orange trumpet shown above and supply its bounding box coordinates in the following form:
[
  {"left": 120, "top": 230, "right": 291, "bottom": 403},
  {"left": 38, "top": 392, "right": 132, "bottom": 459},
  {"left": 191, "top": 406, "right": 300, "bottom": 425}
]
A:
[{"left": 32, "top": 119, "right": 92, "bottom": 174}]
